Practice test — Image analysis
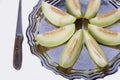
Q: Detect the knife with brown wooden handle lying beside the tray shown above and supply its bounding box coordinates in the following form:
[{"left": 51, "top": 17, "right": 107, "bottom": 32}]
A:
[{"left": 13, "top": 0, "right": 23, "bottom": 70}]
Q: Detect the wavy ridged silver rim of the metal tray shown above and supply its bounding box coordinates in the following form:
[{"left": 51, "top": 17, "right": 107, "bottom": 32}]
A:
[{"left": 26, "top": 0, "right": 120, "bottom": 80}]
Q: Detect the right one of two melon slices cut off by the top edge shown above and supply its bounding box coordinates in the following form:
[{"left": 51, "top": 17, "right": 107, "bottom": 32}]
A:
[{"left": 84, "top": 0, "right": 101, "bottom": 19}]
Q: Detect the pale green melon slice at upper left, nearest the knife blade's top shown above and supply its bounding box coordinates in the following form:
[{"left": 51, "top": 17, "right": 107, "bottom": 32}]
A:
[{"left": 42, "top": 1, "right": 76, "bottom": 27}]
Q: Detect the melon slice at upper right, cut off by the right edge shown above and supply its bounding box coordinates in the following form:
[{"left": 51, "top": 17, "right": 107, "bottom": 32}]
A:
[{"left": 90, "top": 8, "right": 120, "bottom": 27}]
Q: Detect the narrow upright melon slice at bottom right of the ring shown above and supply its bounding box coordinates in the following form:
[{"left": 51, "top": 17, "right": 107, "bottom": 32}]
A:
[{"left": 83, "top": 30, "right": 108, "bottom": 68}]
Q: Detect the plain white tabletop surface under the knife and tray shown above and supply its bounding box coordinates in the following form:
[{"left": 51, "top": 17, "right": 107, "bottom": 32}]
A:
[{"left": 0, "top": 0, "right": 120, "bottom": 80}]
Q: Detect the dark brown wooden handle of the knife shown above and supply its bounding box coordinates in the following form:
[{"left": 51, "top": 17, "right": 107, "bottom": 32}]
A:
[{"left": 13, "top": 36, "right": 23, "bottom": 70}]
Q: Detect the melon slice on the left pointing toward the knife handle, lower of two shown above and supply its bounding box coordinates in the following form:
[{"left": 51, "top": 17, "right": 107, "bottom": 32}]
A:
[{"left": 35, "top": 24, "right": 75, "bottom": 47}]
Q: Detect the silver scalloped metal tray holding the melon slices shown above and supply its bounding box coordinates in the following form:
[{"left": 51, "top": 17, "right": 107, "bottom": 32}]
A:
[{"left": 26, "top": 0, "right": 120, "bottom": 80}]
